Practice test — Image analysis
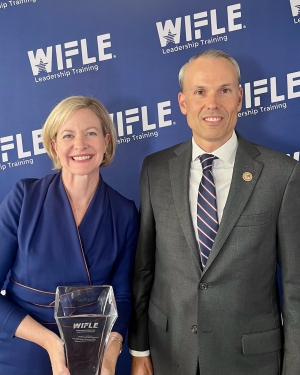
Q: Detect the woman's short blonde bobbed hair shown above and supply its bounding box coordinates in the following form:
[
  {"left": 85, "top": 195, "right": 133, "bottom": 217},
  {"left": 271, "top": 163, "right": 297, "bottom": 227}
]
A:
[{"left": 42, "top": 96, "right": 117, "bottom": 170}]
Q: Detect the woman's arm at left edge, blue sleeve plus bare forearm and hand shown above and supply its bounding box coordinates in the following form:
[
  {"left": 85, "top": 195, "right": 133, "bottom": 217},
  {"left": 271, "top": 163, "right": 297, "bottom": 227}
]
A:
[{"left": 0, "top": 181, "right": 70, "bottom": 375}]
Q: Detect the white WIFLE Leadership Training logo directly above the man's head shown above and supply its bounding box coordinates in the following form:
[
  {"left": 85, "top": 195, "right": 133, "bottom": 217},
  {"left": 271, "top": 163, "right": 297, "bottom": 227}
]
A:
[{"left": 156, "top": 3, "right": 245, "bottom": 54}]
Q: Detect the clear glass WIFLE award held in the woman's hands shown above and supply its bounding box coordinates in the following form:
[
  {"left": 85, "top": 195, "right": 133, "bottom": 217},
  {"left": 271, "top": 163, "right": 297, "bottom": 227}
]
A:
[{"left": 54, "top": 285, "right": 118, "bottom": 375}]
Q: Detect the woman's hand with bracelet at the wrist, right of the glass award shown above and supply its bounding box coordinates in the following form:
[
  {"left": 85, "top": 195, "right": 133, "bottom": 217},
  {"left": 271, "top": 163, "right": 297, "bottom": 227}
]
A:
[{"left": 101, "top": 332, "right": 123, "bottom": 375}]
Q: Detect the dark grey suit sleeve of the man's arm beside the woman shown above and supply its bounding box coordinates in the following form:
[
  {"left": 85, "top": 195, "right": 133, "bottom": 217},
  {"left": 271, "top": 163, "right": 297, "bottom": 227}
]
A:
[{"left": 128, "top": 158, "right": 156, "bottom": 352}]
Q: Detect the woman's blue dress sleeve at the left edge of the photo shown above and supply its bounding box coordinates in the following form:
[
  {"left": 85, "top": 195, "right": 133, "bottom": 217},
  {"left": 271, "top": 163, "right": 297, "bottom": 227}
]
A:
[{"left": 0, "top": 181, "right": 27, "bottom": 337}]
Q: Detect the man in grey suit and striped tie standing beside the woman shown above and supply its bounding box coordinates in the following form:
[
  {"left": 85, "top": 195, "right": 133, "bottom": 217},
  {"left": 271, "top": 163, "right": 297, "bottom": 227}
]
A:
[{"left": 129, "top": 50, "right": 300, "bottom": 375}]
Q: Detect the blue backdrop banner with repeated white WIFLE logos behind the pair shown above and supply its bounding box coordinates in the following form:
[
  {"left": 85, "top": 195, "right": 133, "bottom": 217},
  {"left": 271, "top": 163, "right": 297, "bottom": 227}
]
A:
[{"left": 0, "top": 0, "right": 300, "bottom": 375}]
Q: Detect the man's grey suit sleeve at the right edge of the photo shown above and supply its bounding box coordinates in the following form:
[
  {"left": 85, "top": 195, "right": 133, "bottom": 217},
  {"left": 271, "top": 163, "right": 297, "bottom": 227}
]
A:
[{"left": 278, "top": 163, "right": 300, "bottom": 375}]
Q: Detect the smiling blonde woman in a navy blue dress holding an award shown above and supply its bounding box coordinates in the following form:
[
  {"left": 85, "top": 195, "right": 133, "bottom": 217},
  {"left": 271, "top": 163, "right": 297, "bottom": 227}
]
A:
[{"left": 0, "top": 96, "right": 138, "bottom": 375}]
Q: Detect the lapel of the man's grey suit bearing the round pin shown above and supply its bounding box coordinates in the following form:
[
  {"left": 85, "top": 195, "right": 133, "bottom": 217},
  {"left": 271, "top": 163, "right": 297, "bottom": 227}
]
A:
[{"left": 203, "top": 133, "right": 263, "bottom": 274}]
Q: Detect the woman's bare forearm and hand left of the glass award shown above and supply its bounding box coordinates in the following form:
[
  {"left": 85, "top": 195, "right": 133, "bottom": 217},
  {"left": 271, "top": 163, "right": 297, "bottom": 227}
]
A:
[{"left": 15, "top": 315, "right": 70, "bottom": 375}]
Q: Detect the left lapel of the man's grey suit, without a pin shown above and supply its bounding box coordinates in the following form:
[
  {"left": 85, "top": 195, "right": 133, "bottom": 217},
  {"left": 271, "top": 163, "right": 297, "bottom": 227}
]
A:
[{"left": 169, "top": 141, "right": 201, "bottom": 271}]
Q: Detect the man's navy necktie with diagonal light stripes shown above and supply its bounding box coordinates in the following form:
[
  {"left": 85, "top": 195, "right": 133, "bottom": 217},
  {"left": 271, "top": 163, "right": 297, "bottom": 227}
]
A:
[{"left": 197, "top": 154, "right": 219, "bottom": 268}]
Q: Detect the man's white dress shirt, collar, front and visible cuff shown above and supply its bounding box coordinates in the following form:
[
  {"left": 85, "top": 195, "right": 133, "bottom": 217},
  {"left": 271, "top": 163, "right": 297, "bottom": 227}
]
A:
[{"left": 129, "top": 132, "right": 238, "bottom": 357}]
